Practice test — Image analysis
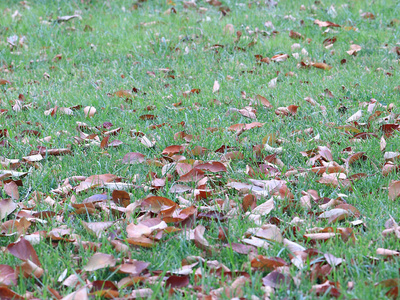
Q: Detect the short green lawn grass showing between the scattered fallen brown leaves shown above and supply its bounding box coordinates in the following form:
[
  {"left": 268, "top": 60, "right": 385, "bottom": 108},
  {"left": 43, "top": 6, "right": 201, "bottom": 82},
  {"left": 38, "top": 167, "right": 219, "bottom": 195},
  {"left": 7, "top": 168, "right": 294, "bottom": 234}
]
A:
[{"left": 0, "top": 0, "right": 400, "bottom": 299}]
